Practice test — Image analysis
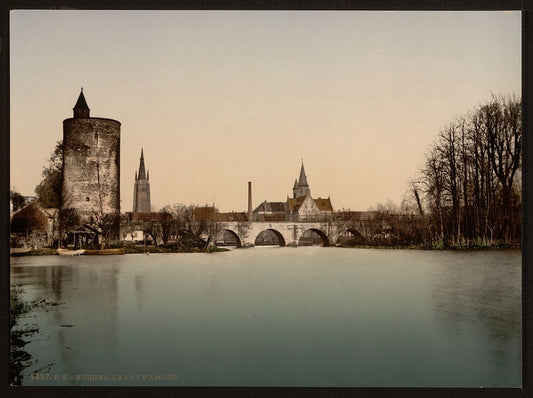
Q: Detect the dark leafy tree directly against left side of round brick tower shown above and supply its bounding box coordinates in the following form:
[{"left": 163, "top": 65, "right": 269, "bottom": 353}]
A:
[{"left": 35, "top": 141, "right": 63, "bottom": 208}]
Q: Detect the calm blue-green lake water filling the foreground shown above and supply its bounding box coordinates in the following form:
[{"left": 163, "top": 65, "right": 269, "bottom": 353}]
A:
[{"left": 11, "top": 247, "right": 522, "bottom": 387}]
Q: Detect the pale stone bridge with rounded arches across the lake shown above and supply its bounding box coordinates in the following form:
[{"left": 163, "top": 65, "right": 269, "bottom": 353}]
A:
[{"left": 214, "top": 220, "right": 388, "bottom": 247}]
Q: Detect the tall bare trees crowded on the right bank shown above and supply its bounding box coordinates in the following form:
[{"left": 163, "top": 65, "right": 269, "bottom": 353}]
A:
[{"left": 397, "top": 95, "right": 522, "bottom": 246}]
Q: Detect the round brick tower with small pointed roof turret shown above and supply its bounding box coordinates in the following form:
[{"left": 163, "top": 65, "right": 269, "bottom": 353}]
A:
[{"left": 62, "top": 89, "right": 120, "bottom": 223}]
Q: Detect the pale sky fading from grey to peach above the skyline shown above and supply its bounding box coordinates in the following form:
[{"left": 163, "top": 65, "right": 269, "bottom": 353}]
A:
[{"left": 10, "top": 10, "right": 521, "bottom": 212}]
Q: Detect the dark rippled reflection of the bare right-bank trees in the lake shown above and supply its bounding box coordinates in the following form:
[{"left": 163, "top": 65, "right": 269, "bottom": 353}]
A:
[{"left": 431, "top": 252, "right": 522, "bottom": 376}]
